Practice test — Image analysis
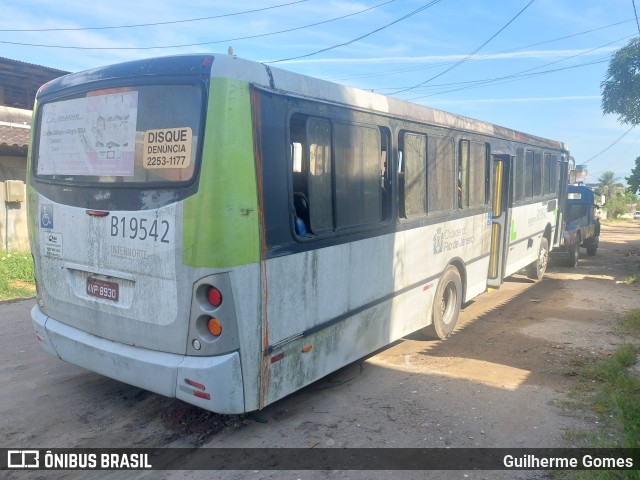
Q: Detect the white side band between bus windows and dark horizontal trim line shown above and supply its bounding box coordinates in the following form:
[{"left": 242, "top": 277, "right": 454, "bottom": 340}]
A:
[{"left": 267, "top": 214, "right": 491, "bottom": 344}]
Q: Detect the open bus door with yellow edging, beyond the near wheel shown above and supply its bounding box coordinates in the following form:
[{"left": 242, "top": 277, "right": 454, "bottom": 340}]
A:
[{"left": 487, "top": 155, "right": 511, "bottom": 288}]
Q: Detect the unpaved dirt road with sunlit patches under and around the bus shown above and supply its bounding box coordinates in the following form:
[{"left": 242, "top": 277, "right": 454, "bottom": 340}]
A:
[{"left": 0, "top": 222, "right": 640, "bottom": 480}]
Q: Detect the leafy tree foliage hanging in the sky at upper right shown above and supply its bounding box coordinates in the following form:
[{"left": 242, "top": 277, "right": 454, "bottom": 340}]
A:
[{"left": 600, "top": 38, "right": 640, "bottom": 125}]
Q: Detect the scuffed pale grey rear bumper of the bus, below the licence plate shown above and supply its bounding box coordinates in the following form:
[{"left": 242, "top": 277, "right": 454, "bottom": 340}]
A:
[{"left": 31, "top": 305, "right": 245, "bottom": 414}]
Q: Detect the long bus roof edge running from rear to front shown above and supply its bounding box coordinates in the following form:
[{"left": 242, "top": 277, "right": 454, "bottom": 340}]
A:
[{"left": 38, "top": 54, "right": 568, "bottom": 151}]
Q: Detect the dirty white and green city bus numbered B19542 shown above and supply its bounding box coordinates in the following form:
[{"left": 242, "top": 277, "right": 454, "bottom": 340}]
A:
[{"left": 28, "top": 51, "right": 568, "bottom": 413}]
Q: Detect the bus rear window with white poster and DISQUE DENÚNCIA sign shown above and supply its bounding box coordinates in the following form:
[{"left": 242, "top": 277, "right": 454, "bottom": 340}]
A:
[{"left": 34, "top": 85, "right": 203, "bottom": 184}]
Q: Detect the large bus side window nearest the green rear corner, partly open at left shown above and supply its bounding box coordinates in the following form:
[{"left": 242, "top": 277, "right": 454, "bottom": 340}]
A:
[{"left": 289, "top": 114, "right": 391, "bottom": 236}]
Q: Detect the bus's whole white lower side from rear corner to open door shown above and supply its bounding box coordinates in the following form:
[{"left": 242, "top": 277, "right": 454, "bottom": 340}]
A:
[{"left": 260, "top": 213, "right": 491, "bottom": 401}]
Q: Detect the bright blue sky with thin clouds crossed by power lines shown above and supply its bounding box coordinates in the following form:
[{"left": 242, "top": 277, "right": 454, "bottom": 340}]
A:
[{"left": 0, "top": 0, "right": 640, "bottom": 185}]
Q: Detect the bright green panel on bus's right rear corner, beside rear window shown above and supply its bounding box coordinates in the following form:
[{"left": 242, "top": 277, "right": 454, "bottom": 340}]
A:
[{"left": 182, "top": 78, "right": 260, "bottom": 268}]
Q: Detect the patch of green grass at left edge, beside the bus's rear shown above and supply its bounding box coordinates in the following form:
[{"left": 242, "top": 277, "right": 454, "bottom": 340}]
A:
[{"left": 0, "top": 251, "right": 35, "bottom": 300}]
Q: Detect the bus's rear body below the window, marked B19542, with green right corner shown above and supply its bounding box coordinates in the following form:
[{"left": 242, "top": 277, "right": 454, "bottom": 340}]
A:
[{"left": 29, "top": 59, "right": 262, "bottom": 413}]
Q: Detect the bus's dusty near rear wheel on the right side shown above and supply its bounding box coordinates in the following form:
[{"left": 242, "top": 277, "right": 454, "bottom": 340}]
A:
[{"left": 422, "top": 265, "right": 462, "bottom": 340}]
